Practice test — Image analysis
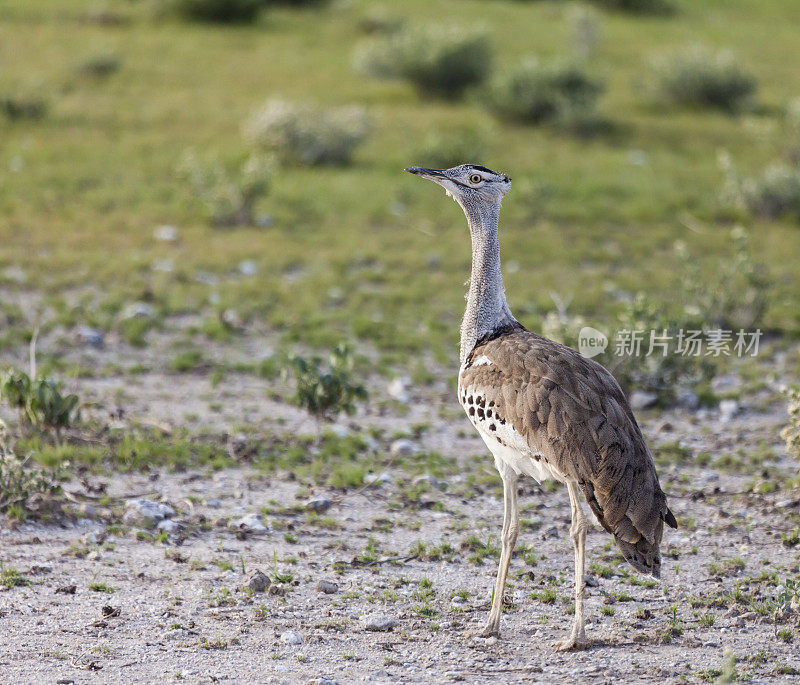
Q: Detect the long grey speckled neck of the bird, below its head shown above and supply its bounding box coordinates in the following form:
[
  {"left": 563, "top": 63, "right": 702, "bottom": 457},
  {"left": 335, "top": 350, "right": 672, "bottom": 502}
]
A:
[{"left": 460, "top": 203, "right": 516, "bottom": 364}]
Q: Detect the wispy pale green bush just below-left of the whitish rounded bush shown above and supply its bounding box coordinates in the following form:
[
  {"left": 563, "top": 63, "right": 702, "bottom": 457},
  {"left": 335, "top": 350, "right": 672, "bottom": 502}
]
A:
[{"left": 179, "top": 153, "right": 274, "bottom": 226}]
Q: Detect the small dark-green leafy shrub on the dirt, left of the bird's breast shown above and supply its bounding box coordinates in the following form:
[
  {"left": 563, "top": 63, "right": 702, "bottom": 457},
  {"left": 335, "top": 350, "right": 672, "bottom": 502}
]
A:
[{"left": 289, "top": 345, "right": 367, "bottom": 421}]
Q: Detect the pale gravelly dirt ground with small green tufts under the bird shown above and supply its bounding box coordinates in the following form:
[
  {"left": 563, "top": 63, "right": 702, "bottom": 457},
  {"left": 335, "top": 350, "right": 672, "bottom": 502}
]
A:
[{"left": 0, "top": 328, "right": 800, "bottom": 683}]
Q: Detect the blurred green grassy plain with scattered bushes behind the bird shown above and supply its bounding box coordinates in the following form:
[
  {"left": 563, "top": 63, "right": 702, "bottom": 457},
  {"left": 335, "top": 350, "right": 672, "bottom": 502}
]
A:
[{"left": 0, "top": 0, "right": 800, "bottom": 406}]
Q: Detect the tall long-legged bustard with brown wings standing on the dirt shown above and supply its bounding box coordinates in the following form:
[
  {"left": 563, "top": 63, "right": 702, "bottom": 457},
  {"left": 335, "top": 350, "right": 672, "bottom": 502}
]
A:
[{"left": 405, "top": 164, "right": 678, "bottom": 650}]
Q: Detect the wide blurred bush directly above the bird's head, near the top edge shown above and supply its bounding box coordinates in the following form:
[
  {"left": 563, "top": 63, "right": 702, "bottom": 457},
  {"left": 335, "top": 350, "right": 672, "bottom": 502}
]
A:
[{"left": 355, "top": 26, "right": 492, "bottom": 98}]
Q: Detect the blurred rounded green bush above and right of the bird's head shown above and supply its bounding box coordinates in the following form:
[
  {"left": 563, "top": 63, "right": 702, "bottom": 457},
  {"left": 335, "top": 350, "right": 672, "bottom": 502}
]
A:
[{"left": 487, "top": 58, "right": 603, "bottom": 126}]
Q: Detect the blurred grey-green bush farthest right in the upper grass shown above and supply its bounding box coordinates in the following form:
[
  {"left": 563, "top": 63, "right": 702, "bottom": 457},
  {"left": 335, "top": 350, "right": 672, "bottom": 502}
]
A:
[{"left": 656, "top": 46, "right": 756, "bottom": 112}]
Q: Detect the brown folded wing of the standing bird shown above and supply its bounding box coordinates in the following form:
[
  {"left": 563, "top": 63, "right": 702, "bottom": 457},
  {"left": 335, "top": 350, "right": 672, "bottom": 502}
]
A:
[{"left": 461, "top": 324, "right": 677, "bottom": 575}]
